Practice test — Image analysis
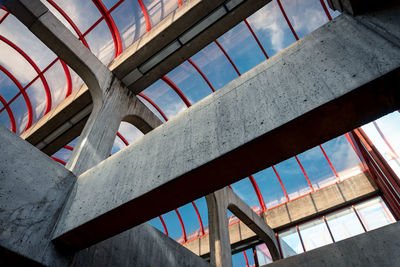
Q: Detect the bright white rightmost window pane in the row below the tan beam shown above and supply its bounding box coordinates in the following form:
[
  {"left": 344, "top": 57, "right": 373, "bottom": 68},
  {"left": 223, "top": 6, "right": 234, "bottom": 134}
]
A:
[{"left": 354, "top": 197, "right": 395, "bottom": 231}]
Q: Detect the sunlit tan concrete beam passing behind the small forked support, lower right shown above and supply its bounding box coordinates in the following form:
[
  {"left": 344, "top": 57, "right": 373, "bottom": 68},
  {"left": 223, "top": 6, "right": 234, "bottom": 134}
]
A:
[{"left": 183, "top": 172, "right": 378, "bottom": 258}]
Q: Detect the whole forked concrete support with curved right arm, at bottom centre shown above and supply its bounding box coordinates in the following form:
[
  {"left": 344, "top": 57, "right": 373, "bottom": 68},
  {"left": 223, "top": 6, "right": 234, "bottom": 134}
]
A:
[{"left": 206, "top": 187, "right": 281, "bottom": 267}]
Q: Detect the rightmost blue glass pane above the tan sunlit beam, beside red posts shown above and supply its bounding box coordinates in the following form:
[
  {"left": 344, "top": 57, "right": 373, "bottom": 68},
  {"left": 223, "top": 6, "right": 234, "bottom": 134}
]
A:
[{"left": 321, "top": 135, "right": 363, "bottom": 180}]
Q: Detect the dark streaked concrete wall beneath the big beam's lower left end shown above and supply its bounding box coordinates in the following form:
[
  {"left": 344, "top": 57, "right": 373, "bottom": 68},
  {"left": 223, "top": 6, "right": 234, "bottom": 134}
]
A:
[{"left": 71, "top": 224, "right": 210, "bottom": 267}]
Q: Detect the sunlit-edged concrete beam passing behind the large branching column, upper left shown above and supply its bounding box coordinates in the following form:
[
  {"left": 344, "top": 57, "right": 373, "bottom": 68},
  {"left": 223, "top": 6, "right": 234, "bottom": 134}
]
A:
[{"left": 22, "top": 0, "right": 270, "bottom": 155}]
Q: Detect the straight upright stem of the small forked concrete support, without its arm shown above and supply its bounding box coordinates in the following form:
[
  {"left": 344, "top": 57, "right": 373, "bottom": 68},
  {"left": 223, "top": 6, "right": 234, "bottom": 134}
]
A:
[{"left": 206, "top": 189, "right": 232, "bottom": 267}]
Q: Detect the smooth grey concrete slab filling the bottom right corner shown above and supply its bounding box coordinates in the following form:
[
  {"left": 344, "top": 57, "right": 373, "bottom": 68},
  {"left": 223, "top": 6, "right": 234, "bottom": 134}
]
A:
[{"left": 265, "top": 222, "right": 400, "bottom": 267}]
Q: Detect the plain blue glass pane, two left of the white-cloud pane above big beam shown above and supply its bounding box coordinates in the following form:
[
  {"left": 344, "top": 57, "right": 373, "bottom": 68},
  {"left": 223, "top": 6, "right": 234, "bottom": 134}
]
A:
[{"left": 191, "top": 42, "right": 238, "bottom": 90}]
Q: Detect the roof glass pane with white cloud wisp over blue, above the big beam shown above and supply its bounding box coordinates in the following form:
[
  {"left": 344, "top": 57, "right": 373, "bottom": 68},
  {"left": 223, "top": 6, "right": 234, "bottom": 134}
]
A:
[{"left": 247, "top": 1, "right": 296, "bottom": 57}]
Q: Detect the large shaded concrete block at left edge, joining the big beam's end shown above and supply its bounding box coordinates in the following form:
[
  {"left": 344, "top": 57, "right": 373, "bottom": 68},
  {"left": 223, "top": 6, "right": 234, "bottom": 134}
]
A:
[{"left": 0, "top": 126, "right": 76, "bottom": 266}]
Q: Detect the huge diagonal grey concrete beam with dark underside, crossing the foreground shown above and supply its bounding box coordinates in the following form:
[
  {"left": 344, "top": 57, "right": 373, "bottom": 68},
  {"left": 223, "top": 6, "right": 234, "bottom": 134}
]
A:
[{"left": 55, "top": 9, "right": 400, "bottom": 249}]
